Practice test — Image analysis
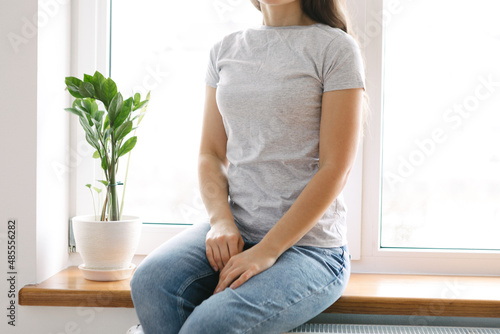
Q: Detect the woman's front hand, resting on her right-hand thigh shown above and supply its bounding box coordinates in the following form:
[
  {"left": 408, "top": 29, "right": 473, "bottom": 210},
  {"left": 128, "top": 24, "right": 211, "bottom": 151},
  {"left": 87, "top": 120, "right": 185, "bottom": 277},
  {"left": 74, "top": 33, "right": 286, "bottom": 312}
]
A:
[{"left": 214, "top": 244, "right": 278, "bottom": 294}]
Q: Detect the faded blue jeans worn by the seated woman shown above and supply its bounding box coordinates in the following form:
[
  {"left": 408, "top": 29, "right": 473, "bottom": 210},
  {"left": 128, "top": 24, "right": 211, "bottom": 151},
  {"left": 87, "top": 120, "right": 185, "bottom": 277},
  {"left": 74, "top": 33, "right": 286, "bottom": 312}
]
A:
[{"left": 131, "top": 223, "right": 350, "bottom": 334}]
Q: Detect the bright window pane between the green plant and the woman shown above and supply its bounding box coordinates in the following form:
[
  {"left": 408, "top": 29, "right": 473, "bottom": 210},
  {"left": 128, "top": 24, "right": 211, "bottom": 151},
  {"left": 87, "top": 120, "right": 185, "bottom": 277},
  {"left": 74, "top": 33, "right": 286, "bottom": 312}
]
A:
[{"left": 111, "top": 0, "right": 261, "bottom": 223}]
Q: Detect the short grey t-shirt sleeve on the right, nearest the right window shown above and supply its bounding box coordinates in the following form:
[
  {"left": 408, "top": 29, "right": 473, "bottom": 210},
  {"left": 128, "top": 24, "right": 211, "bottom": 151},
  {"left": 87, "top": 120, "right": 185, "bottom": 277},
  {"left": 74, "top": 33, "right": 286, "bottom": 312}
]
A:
[{"left": 323, "top": 34, "right": 365, "bottom": 92}]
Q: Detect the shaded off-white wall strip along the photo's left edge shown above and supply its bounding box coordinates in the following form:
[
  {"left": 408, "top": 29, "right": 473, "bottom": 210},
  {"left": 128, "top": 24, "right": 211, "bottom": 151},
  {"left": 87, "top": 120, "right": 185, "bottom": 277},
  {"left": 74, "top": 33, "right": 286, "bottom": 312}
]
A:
[{"left": 0, "top": 0, "right": 37, "bottom": 333}]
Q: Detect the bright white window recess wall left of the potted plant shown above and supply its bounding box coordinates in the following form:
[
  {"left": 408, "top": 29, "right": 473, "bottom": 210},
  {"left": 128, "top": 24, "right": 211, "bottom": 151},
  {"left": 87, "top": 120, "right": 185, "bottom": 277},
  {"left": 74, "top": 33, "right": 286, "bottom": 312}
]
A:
[{"left": 36, "top": 0, "right": 71, "bottom": 288}]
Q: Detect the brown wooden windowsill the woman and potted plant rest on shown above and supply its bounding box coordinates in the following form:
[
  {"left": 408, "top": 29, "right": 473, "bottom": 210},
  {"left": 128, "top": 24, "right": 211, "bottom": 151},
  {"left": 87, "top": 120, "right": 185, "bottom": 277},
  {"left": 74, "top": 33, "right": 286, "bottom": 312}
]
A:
[{"left": 19, "top": 267, "right": 500, "bottom": 318}]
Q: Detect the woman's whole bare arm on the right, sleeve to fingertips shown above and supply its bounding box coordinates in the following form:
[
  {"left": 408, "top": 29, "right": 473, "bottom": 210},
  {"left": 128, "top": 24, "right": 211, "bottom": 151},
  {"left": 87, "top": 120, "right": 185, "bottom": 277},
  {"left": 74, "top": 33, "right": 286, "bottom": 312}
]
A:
[{"left": 216, "top": 88, "right": 363, "bottom": 293}]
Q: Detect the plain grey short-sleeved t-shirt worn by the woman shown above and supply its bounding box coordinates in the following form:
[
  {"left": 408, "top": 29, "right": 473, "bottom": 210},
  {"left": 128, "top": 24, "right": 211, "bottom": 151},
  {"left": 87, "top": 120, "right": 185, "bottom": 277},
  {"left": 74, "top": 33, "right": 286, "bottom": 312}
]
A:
[{"left": 206, "top": 24, "right": 364, "bottom": 247}]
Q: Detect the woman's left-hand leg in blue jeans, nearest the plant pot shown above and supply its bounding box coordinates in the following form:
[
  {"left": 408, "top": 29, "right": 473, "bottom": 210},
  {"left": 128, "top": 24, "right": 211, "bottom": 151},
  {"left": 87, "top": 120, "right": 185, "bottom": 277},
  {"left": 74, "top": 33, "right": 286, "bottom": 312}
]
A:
[{"left": 131, "top": 223, "right": 219, "bottom": 333}]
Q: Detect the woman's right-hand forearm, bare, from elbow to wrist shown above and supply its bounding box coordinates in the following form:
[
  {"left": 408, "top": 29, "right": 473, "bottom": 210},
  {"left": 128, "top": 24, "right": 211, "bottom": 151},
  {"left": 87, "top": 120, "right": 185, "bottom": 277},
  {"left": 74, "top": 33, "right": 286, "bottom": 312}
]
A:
[{"left": 260, "top": 166, "right": 349, "bottom": 257}]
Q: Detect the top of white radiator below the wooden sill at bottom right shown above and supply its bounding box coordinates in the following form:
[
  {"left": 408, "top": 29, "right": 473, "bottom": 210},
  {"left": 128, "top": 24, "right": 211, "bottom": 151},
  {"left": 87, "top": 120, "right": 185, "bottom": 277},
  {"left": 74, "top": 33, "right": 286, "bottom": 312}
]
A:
[{"left": 288, "top": 324, "right": 500, "bottom": 334}]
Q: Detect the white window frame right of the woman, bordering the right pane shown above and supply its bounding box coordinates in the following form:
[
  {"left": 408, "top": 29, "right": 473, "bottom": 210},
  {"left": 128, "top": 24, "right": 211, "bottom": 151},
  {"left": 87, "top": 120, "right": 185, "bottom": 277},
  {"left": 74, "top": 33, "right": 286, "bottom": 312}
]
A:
[{"left": 352, "top": 0, "right": 500, "bottom": 275}]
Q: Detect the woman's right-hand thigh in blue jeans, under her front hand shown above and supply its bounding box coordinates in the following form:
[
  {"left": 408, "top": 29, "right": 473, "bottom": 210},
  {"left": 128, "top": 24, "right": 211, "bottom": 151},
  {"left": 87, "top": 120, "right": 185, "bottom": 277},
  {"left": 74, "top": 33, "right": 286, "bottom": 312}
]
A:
[{"left": 180, "top": 246, "right": 350, "bottom": 334}]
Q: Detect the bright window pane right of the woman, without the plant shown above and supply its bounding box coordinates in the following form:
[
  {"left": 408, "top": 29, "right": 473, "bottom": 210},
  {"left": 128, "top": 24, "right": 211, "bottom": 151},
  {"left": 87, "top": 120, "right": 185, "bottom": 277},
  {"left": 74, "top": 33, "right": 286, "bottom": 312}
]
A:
[{"left": 381, "top": 0, "right": 500, "bottom": 249}]
